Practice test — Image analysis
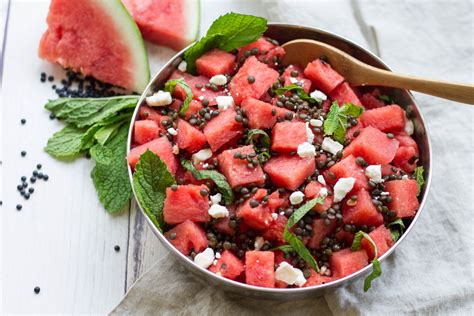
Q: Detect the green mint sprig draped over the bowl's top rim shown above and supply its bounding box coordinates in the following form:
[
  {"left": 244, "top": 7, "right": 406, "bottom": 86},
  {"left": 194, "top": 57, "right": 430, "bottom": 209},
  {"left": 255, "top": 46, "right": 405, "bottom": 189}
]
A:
[{"left": 184, "top": 12, "right": 267, "bottom": 74}]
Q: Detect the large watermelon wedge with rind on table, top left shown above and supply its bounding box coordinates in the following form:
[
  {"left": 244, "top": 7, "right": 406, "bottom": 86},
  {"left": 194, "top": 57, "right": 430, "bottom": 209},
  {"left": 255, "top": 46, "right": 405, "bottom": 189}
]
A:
[{"left": 39, "top": 0, "right": 150, "bottom": 92}]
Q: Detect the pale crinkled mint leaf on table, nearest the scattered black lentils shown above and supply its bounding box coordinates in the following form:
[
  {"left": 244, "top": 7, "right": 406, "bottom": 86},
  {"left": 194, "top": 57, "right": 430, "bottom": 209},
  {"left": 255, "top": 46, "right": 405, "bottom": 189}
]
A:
[{"left": 44, "top": 126, "right": 86, "bottom": 159}]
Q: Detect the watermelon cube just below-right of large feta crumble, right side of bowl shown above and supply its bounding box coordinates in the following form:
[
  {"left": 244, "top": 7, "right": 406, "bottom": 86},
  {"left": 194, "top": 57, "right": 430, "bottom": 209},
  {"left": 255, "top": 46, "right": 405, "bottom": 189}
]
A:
[{"left": 342, "top": 189, "right": 383, "bottom": 226}]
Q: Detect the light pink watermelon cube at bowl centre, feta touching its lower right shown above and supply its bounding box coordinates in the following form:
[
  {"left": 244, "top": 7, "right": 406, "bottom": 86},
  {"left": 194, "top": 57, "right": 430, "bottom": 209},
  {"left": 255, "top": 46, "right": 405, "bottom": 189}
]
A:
[{"left": 272, "top": 122, "right": 308, "bottom": 153}]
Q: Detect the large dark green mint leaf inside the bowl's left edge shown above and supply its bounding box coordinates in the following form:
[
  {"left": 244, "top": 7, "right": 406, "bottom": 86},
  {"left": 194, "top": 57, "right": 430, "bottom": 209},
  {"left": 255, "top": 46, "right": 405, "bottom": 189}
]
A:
[{"left": 133, "top": 150, "right": 175, "bottom": 231}]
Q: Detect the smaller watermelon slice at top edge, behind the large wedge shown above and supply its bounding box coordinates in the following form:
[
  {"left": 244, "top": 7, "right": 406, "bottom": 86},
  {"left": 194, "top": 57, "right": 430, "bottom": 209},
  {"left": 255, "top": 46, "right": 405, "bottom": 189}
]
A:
[{"left": 122, "top": 0, "right": 200, "bottom": 50}]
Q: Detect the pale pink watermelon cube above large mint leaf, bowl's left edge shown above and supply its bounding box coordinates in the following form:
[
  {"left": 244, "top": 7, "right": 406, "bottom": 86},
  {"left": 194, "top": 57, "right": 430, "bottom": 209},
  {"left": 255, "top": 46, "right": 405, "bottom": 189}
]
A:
[{"left": 127, "top": 136, "right": 178, "bottom": 174}]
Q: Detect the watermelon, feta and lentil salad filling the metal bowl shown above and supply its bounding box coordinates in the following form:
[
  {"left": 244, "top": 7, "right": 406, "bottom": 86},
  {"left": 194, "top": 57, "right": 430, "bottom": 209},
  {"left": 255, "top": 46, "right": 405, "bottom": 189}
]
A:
[{"left": 128, "top": 38, "right": 419, "bottom": 288}]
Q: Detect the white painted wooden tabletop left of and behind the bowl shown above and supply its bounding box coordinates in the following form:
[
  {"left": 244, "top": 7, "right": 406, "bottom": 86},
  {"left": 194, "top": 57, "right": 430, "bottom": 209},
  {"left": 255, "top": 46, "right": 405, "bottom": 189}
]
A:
[{"left": 0, "top": 0, "right": 265, "bottom": 314}]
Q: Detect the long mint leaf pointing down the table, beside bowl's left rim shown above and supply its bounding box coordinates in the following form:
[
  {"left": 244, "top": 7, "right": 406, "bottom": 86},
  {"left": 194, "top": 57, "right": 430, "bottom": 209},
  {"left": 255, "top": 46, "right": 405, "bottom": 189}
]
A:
[{"left": 91, "top": 125, "right": 132, "bottom": 213}]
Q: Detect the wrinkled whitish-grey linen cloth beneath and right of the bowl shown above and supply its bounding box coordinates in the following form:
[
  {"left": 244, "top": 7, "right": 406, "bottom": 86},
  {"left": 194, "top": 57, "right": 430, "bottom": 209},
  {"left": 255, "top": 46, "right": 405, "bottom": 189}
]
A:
[{"left": 111, "top": 0, "right": 474, "bottom": 315}]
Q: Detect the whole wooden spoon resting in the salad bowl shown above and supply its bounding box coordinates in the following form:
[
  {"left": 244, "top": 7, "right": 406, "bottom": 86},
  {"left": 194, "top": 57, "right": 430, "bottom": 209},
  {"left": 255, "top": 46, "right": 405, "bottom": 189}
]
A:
[{"left": 283, "top": 39, "right": 474, "bottom": 104}]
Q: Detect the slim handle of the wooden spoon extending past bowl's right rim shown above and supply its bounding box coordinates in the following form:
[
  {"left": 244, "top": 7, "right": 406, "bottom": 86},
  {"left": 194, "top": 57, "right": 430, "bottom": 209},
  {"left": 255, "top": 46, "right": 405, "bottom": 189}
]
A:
[{"left": 359, "top": 66, "right": 474, "bottom": 104}]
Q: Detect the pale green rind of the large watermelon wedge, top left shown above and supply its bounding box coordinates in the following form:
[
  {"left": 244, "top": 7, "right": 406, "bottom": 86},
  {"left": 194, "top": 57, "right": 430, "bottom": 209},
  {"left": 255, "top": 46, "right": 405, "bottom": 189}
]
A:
[{"left": 97, "top": 0, "right": 150, "bottom": 93}]
